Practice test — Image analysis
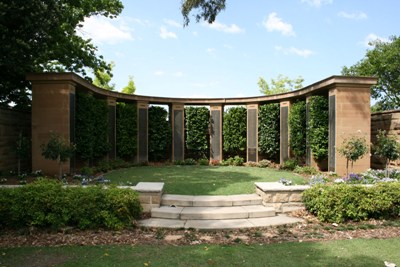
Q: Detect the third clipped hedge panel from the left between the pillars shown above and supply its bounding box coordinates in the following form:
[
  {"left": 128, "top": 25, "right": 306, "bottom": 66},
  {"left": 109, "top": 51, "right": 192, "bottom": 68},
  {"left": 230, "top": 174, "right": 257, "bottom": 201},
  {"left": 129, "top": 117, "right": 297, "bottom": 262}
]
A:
[{"left": 149, "top": 106, "right": 172, "bottom": 161}]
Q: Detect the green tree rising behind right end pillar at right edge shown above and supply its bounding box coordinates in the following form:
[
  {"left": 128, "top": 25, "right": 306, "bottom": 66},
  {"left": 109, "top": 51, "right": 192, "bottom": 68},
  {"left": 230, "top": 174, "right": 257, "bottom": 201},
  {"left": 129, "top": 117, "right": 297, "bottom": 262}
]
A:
[{"left": 342, "top": 36, "right": 400, "bottom": 110}]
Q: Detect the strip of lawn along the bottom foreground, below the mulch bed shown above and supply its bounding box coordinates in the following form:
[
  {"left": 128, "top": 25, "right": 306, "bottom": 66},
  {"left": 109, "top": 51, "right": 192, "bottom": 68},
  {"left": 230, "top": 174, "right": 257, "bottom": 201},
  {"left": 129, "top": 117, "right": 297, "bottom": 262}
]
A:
[{"left": 0, "top": 238, "right": 400, "bottom": 267}]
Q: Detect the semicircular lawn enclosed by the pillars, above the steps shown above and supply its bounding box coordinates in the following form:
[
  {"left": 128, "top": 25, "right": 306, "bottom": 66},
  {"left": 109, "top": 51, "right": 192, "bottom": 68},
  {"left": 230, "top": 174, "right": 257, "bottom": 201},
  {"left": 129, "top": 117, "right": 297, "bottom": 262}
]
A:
[{"left": 105, "top": 165, "right": 304, "bottom": 195}]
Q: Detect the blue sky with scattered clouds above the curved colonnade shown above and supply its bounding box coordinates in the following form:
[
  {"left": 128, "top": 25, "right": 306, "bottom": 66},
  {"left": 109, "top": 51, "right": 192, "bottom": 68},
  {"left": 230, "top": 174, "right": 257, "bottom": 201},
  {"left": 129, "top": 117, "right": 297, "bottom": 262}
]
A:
[{"left": 79, "top": 0, "right": 400, "bottom": 98}]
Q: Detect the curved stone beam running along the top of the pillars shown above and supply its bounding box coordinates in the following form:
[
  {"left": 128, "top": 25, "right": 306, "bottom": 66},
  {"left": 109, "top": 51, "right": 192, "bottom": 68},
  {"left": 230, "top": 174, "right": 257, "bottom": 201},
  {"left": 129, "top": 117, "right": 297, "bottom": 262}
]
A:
[{"left": 26, "top": 72, "right": 377, "bottom": 105}]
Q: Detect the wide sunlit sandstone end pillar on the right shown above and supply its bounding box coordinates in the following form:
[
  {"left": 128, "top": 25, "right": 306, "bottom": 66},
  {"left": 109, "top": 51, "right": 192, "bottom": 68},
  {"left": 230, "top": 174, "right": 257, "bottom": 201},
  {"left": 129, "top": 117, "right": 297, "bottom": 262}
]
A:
[{"left": 328, "top": 84, "right": 371, "bottom": 175}]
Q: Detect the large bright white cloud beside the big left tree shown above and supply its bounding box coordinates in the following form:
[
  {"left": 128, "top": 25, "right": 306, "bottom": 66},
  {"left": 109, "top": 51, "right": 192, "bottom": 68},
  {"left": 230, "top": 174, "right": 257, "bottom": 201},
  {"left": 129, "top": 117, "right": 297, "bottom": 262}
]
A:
[{"left": 78, "top": 16, "right": 134, "bottom": 44}]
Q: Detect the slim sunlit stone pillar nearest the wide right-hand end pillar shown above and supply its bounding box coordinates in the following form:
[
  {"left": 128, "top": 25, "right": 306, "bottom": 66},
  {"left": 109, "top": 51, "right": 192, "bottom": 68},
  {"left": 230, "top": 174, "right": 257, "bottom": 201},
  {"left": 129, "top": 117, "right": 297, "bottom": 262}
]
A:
[{"left": 280, "top": 101, "right": 290, "bottom": 164}]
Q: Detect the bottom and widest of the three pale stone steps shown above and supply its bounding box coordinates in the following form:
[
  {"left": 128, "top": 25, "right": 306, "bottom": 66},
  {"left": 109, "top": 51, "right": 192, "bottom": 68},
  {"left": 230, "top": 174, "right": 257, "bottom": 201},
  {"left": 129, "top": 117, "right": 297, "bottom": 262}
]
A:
[{"left": 139, "top": 214, "right": 303, "bottom": 230}]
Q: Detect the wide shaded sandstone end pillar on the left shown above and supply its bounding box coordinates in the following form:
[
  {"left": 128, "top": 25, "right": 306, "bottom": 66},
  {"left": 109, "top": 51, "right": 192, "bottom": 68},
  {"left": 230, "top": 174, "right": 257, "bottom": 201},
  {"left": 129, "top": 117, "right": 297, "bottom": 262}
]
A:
[{"left": 31, "top": 80, "right": 76, "bottom": 175}]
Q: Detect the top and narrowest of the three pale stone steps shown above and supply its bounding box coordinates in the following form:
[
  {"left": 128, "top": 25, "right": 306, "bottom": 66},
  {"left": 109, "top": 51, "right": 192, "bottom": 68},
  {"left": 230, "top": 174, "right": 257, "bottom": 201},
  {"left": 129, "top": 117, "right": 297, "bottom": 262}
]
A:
[{"left": 161, "top": 194, "right": 262, "bottom": 207}]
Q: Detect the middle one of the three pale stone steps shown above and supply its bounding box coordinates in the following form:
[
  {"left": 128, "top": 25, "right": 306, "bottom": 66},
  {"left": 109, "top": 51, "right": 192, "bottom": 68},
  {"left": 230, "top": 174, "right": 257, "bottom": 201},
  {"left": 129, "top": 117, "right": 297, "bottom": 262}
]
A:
[{"left": 151, "top": 205, "right": 276, "bottom": 220}]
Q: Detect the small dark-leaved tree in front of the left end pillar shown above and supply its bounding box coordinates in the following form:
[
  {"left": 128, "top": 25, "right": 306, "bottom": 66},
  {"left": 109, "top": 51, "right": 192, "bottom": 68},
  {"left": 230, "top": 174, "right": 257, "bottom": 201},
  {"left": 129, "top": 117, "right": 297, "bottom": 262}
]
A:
[{"left": 40, "top": 132, "right": 75, "bottom": 179}]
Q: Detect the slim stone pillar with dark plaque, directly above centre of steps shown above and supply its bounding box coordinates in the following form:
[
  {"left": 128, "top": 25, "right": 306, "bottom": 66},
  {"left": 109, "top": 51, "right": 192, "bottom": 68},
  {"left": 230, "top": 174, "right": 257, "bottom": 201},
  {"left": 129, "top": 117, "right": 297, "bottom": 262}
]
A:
[{"left": 210, "top": 105, "right": 224, "bottom": 162}]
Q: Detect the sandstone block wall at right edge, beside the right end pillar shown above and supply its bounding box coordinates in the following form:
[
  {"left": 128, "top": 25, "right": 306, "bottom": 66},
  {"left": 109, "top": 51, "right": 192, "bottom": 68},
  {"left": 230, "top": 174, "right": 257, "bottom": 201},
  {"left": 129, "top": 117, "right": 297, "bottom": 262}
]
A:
[{"left": 371, "top": 110, "right": 400, "bottom": 169}]
